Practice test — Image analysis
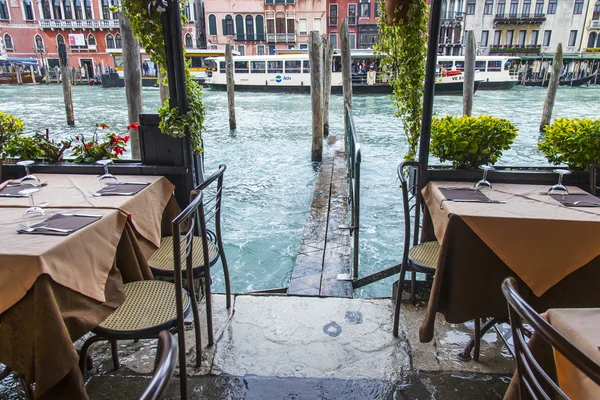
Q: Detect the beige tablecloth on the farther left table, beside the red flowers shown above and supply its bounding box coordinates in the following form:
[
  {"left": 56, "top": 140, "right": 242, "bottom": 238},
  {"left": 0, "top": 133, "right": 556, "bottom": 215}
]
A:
[{"left": 0, "top": 174, "right": 175, "bottom": 247}]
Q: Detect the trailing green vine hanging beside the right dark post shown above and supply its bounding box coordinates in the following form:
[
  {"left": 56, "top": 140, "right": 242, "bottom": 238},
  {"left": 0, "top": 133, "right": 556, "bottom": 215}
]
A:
[{"left": 374, "top": 0, "right": 428, "bottom": 160}]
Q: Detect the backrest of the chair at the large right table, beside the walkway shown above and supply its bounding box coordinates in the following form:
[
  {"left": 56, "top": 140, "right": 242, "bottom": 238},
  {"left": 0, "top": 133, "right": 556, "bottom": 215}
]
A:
[{"left": 397, "top": 161, "right": 423, "bottom": 264}]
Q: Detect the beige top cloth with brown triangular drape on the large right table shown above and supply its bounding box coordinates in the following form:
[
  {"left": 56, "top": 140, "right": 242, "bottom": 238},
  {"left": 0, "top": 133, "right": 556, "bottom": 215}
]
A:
[{"left": 423, "top": 182, "right": 600, "bottom": 296}]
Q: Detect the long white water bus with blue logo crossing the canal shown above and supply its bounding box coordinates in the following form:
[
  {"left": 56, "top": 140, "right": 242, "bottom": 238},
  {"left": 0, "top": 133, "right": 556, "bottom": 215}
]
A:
[{"left": 205, "top": 52, "right": 481, "bottom": 94}]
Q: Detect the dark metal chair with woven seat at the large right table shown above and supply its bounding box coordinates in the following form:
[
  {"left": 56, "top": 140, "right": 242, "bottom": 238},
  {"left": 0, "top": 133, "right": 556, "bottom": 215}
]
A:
[{"left": 393, "top": 161, "right": 440, "bottom": 337}]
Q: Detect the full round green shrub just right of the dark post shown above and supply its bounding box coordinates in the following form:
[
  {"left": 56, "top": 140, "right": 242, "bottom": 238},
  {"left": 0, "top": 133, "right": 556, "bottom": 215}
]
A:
[{"left": 430, "top": 115, "right": 518, "bottom": 169}]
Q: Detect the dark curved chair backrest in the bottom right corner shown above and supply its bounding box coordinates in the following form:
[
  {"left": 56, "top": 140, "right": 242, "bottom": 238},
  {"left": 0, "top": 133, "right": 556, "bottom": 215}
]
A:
[{"left": 502, "top": 278, "right": 600, "bottom": 399}]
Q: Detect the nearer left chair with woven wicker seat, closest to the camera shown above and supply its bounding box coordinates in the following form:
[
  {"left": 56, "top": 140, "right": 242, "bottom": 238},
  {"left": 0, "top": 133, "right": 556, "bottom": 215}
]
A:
[{"left": 79, "top": 191, "right": 209, "bottom": 399}]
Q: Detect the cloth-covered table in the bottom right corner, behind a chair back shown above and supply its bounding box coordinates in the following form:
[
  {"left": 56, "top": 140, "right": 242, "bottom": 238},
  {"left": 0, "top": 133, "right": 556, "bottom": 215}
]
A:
[{"left": 504, "top": 308, "right": 600, "bottom": 400}]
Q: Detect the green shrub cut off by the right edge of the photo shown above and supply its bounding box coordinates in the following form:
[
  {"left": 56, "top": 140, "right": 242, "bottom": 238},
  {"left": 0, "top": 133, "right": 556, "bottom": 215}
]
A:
[{"left": 538, "top": 118, "right": 600, "bottom": 170}]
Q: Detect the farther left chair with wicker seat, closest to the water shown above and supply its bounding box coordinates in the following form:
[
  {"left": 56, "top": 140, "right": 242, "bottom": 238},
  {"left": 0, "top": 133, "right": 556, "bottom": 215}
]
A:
[{"left": 148, "top": 164, "right": 231, "bottom": 346}]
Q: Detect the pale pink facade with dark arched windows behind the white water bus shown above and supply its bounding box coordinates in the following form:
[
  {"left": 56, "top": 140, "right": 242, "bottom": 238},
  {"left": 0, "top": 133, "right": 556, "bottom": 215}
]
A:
[{"left": 204, "top": 0, "right": 327, "bottom": 55}]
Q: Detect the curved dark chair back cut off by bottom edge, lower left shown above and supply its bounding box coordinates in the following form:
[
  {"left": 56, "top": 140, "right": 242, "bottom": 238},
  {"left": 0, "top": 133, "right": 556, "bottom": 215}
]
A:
[{"left": 140, "top": 331, "right": 177, "bottom": 400}]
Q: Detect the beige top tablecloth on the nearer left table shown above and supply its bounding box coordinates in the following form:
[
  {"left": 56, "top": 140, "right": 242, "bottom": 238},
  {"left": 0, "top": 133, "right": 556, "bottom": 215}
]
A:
[{"left": 0, "top": 207, "right": 127, "bottom": 314}]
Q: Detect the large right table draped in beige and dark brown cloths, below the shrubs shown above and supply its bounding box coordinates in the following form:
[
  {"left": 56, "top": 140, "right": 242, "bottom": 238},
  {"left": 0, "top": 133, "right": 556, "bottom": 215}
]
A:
[{"left": 419, "top": 182, "right": 600, "bottom": 342}]
